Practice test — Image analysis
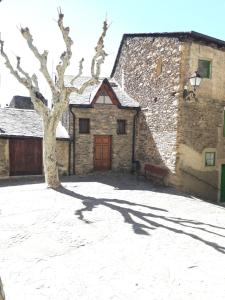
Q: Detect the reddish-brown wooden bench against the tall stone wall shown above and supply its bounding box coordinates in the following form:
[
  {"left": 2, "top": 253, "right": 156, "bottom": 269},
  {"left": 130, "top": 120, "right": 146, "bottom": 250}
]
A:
[{"left": 144, "top": 164, "right": 169, "bottom": 184}]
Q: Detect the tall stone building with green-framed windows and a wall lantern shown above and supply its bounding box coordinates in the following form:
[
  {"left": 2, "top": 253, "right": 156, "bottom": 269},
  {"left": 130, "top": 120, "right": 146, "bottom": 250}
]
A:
[{"left": 111, "top": 32, "right": 225, "bottom": 201}]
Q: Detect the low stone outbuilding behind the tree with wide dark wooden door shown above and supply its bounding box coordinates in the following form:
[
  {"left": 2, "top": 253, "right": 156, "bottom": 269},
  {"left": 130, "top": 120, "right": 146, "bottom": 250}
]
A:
[{"left": 0, "top": 107, "right": 69, "bottom": 178}]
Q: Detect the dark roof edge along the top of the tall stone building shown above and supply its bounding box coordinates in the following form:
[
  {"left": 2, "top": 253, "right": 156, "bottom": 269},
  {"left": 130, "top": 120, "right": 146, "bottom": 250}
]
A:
[{"left": 111, "top": 31, "right": 225, "bottom": 77}]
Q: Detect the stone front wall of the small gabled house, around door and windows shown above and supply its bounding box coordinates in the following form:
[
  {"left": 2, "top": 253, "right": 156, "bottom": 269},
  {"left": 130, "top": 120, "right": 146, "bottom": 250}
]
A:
[{"left": 70, "top": 104, "right": 136, "bottom": 174}]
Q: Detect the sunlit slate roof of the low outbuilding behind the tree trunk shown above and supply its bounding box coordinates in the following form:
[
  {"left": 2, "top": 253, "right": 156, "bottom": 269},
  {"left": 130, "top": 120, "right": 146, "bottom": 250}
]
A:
[{"left": 0, "top": 108, "right": 69, "bottom": 139}]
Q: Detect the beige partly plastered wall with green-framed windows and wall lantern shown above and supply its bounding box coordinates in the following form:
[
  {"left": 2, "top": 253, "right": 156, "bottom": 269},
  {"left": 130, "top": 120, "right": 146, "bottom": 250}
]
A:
[{"left": 177, "top": 41, "right": 225, "bottom": 200}]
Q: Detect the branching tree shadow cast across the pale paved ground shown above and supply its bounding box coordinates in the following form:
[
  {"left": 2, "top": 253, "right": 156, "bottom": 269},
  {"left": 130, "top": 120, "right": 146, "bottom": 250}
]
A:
[{"left": 55, "top": 186, "right": 225, "bottom": 253}]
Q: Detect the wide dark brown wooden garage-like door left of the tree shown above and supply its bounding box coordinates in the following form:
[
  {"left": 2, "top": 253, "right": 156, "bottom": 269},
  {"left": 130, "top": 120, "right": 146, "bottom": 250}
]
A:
[{"left": 9, "top": 139, "right": 42, "bottom": 176}]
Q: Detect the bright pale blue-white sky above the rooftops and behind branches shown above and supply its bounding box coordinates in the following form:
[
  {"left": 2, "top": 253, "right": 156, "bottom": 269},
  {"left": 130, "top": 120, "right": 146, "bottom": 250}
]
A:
[{"left": 0, "top": 0, "right": 225, "bottom": 103}]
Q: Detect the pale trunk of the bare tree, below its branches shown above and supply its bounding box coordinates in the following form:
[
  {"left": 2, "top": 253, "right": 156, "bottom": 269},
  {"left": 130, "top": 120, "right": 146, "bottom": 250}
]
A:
[{"left": 43, "top": 119, "right": 60, "bottom": 188}]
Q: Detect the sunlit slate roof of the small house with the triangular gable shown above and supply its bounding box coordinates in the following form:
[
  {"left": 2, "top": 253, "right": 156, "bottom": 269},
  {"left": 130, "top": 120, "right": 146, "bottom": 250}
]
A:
[{"left": 65, "top": 75, "right": 139, "bottom": 108}]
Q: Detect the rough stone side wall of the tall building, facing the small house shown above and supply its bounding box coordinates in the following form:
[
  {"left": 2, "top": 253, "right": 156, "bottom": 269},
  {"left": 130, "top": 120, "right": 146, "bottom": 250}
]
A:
[{"left": 114, "top": 37, "right": 181, "bottom": 178}]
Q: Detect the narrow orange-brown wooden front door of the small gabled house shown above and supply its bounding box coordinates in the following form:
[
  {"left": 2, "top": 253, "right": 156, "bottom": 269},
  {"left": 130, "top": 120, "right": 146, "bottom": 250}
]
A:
[{"left": 94, "top": 135, "right": 112, "bottom": 171}]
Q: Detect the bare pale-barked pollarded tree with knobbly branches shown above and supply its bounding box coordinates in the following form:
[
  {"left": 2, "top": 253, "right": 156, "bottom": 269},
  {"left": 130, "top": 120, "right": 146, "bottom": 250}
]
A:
[{"left": 0, "top": 9, "right": 108, "bottom": 188}]
